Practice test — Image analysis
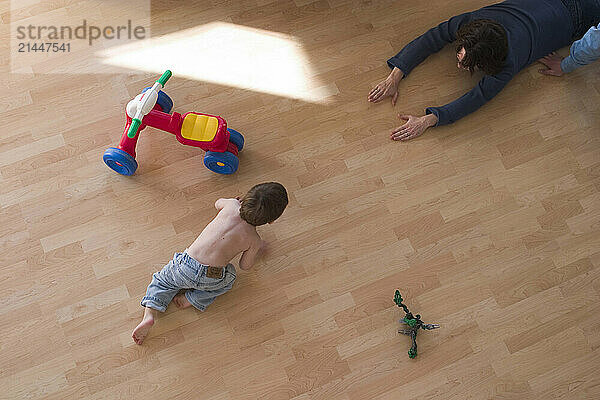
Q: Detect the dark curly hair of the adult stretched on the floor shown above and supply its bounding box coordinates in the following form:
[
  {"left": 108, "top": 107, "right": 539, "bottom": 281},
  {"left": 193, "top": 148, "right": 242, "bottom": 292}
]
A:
[{"left": 455, "top": 19, "right": 508, "bottom": 75}]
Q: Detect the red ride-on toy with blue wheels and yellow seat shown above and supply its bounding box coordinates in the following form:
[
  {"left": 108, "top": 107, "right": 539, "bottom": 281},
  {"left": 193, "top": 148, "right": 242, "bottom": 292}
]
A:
[{"left": 102, "top": 70, "right": 244, "bottom": 175}]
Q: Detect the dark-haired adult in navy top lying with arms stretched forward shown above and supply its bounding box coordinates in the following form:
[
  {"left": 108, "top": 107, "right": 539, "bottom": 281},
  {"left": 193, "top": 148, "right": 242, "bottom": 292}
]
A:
[{"left": 368, "top": 0, "right": 600, "bottom": 140}]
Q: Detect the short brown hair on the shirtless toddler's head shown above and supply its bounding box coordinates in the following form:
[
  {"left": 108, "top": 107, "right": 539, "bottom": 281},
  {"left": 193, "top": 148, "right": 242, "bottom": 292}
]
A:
[{"left": 240, "top": 182, "right": 288, "bottom": 226}]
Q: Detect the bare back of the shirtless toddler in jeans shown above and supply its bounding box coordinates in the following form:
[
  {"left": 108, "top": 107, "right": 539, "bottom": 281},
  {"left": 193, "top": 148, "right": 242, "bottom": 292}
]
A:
[{"left": 187, "top": 199, "right": 260, "bottom": 267}]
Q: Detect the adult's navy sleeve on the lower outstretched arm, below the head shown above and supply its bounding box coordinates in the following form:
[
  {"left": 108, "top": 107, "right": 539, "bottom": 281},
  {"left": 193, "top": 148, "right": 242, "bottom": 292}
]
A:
[{"left": 426, "top": 69, "right": 513, "bottom": 126}]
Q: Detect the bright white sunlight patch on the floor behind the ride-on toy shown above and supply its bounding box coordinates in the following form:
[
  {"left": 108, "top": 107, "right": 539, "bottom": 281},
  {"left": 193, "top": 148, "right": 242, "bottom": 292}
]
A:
[{"left": 100, "top": 22, "right": 337, "bottom": 103}]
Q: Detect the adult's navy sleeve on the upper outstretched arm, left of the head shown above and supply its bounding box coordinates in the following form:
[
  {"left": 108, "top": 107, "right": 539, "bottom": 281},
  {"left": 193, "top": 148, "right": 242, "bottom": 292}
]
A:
[{"left": 388, "top": 13, "right": 472, "bottom": 76}]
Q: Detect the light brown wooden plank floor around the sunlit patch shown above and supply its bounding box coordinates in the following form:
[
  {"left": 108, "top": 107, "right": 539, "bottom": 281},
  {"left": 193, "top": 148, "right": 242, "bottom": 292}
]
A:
[{"left": 0, "top": 0, "right": 600, "bottom": 400}]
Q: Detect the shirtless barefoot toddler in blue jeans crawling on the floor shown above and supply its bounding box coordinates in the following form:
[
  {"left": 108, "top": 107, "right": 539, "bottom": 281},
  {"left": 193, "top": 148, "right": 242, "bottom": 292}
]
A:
[{"left": 131, "top": 182, "right": 288, "bottom": 344}]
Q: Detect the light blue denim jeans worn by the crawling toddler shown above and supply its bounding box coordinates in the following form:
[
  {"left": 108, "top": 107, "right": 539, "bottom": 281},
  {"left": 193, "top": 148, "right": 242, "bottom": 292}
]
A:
[{"left": 142, "top": 253, "right": 235, "bottom": 312}]
